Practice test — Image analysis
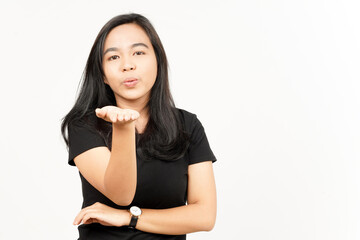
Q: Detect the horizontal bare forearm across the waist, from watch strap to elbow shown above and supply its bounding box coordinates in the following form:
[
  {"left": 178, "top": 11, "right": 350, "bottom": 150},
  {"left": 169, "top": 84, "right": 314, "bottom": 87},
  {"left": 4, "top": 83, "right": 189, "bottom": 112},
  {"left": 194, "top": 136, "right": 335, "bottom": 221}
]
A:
[{"left": 134, "top": 204, "right": 216, "bottom": 235}]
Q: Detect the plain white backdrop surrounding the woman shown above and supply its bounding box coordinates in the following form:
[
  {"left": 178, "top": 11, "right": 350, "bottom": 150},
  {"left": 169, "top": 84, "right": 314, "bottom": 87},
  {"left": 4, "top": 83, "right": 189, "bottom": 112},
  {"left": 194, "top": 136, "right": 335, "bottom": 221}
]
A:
[{"left": 0, "top": 0, "right": 360, "bottom": 240}]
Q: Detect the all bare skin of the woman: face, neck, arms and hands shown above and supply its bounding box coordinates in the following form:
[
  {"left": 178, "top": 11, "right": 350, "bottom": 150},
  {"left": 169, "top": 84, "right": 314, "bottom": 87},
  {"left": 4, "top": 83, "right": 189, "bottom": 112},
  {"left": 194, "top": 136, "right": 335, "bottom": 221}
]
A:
[{"left": 73, "top": 24, "right": 216, "bottom": 235}]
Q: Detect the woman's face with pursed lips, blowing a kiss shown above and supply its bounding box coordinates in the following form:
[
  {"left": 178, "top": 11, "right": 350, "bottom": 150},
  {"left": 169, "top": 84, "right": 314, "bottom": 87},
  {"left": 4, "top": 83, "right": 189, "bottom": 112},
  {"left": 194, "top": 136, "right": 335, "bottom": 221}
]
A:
[{"left": 103, "top": 23, "right": 157, "bottom": 107}]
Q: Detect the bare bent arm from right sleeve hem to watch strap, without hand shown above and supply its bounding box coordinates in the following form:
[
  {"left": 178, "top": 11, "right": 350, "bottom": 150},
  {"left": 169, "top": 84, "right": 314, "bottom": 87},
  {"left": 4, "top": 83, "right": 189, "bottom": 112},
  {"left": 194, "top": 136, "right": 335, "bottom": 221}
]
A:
[{"left": 136, "top": 161, "right": 216, "bottom": 235}]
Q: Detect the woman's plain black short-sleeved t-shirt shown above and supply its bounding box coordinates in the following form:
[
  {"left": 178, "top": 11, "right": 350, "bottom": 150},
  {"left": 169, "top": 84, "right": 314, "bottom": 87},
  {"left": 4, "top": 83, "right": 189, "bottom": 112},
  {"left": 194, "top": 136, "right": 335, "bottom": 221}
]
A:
[{"left": 68, "top": 109, "right": 216, "bottom": 240}]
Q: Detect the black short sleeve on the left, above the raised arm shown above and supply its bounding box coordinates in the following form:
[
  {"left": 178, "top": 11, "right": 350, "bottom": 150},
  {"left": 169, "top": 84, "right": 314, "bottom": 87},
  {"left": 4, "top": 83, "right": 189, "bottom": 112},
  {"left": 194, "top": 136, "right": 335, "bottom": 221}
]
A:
[{"left": 68, "top": 124, "right": 106, "bottom": 166}]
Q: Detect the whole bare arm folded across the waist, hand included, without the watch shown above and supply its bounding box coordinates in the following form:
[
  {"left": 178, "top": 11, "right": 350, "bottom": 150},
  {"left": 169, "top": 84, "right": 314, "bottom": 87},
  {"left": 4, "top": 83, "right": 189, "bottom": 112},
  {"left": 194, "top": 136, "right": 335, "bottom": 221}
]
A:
[{"left": 74, "top": 161, "right": 216, "bottom": 235}]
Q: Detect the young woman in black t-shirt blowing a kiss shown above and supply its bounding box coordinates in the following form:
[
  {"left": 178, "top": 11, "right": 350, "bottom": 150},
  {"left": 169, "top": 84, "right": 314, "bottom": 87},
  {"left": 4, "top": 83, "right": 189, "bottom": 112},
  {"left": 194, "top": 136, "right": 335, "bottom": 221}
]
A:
[{"left": 61, "top": 14, "right": 216, "bottom": 240}]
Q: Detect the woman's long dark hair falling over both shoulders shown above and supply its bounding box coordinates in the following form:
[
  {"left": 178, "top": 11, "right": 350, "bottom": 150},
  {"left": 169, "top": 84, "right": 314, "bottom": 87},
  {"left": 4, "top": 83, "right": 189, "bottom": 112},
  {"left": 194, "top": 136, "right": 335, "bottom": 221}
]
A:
[{"left": 61, "top": 13, "right": 189, "bottom": 161}]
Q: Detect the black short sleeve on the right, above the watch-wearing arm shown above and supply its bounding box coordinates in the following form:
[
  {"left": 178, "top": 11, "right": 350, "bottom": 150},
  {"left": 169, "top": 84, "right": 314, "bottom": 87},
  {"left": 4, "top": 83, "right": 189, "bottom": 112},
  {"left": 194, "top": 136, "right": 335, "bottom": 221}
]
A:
[{"left": 188, "top": 114, "right": 216, "bottom": 165}]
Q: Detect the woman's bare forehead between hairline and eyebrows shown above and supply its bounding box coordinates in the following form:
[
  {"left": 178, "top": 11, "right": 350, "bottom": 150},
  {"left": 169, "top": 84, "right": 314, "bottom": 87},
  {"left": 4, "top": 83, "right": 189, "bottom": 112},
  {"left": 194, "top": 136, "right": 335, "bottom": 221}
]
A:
[{"left": 104, "top": 23, "right": 151, "bottom": 49}]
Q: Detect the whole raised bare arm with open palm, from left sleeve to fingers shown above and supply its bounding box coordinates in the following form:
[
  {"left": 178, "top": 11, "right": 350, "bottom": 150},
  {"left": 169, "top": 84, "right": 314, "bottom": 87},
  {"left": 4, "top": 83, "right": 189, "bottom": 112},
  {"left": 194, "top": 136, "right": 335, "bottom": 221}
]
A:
[{"left": 74, "top": 106, "right": 139, "bottom": 206}]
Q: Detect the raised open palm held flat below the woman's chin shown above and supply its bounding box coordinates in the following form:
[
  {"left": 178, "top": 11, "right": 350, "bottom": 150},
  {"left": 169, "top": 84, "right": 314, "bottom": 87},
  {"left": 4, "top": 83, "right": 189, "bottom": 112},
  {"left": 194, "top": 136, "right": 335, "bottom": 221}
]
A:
[{"left": 95, "top": 106, "right": 140, "bottom": 123}]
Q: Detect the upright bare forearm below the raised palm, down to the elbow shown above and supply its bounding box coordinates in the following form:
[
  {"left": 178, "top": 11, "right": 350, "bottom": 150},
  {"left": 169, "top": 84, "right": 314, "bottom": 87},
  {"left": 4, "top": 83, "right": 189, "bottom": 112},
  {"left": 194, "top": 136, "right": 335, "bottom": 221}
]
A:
[{"left": 104, "top": 122, "right": 137, "bottom": 205}]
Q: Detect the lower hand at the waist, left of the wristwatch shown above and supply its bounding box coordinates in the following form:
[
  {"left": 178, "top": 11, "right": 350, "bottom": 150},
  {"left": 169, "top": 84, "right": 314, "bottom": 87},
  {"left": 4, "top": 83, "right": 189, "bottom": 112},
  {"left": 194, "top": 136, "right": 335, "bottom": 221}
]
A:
[{"left": 73, "top": 202, "right": 130, "bottom": 227}]
